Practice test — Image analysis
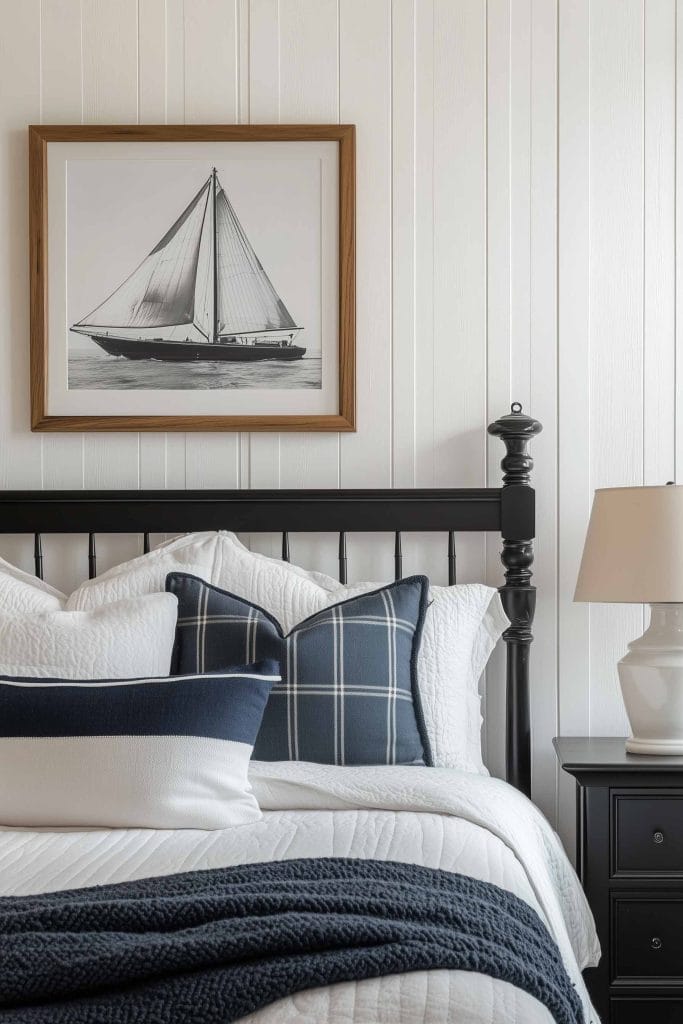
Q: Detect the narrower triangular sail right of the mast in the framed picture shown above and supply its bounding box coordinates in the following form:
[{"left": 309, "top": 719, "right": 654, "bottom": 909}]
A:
[{"left": 216, "top": 187, "right": 296, "bottom": 334}]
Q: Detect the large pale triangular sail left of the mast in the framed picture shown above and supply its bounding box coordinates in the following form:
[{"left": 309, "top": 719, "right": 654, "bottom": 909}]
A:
[{"left": 77, "top": 179, "right": 211, "bottom": 328}]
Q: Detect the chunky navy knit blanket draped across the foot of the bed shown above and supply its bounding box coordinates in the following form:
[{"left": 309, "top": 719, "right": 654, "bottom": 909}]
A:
[{"left": 0, "top": 858, "right": 583, "bottom": 1024}]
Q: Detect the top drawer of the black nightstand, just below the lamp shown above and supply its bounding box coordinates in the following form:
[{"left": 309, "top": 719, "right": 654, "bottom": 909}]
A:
[{"left": 612, "top": 790, "right": 683, "bottom": 876}]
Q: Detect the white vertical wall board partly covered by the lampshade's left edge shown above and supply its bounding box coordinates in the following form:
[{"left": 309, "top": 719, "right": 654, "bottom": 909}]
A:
[{"left": 561, "top": 0, "right": 592, "bottom": 849}]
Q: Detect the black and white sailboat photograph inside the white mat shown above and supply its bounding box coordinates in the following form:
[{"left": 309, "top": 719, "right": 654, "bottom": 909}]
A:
[{"left": 67, "top": 159, "right": 322, "bottom": 390}]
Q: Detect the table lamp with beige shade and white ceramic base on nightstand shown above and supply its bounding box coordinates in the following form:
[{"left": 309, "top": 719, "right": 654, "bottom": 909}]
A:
[{"left": 574, "top": 483, "right": 683, "bottom": 754}]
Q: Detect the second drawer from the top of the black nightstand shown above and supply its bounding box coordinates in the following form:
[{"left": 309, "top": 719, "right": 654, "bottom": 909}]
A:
[{"left": 612, "top": 893, "right": 683, "bottom": 985}]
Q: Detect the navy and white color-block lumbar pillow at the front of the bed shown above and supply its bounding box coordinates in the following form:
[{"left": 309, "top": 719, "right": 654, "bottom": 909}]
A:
[{"left": 0, "top": 660, "right": 281, "bottom": 828}]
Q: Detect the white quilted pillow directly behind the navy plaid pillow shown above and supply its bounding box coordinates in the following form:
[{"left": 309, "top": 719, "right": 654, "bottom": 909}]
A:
[{"left": 67, "top": 531, "right": 508, "bottom": 774}]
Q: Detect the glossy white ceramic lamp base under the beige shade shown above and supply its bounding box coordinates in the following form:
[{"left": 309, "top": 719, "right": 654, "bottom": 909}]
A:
[{"left": 618, "top": 603, "right": 683, "bottom": 754}]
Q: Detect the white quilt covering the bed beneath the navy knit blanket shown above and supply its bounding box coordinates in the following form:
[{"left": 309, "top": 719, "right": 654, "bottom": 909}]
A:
[{"left": 0, "top": 763, "right": 600, "bottom": 1024}]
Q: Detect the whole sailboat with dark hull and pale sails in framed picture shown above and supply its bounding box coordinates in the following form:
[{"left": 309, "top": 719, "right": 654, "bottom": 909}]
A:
[{"left": 72, "top": 173, "right": 306, "bottom": 362}]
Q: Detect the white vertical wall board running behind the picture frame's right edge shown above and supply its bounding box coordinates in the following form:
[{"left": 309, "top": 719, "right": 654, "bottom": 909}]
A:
[{"left": 339, "top": 0, "right": 392, "bottom": 580}]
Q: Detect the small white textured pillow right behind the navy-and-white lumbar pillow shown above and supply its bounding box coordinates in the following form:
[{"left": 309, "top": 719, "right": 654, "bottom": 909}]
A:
[{"left": 0, "top": 594, "right": 177, "bottom": 679}]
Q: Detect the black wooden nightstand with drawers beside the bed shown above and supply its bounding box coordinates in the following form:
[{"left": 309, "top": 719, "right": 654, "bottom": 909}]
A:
[{"left": 554, "top": 738, "right": 683, "bottom": 1024}]
